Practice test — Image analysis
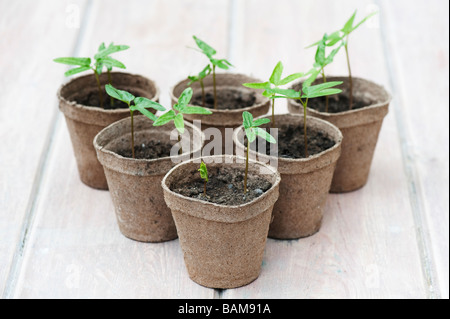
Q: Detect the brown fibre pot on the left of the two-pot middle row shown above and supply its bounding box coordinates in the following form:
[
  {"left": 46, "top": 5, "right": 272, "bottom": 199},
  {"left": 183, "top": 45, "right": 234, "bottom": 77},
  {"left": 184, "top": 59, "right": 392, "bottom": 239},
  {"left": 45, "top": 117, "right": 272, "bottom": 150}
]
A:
[{"left": 94, "top": 115, "right": 203, "bottom": 242}]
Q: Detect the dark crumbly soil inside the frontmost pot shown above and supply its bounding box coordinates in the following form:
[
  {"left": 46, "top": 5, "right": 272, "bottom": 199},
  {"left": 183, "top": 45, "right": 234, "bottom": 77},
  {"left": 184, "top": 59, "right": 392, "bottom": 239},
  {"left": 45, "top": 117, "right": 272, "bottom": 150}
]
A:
[{"left": 170, "top": 164, "right": 272, "bottom": 206}]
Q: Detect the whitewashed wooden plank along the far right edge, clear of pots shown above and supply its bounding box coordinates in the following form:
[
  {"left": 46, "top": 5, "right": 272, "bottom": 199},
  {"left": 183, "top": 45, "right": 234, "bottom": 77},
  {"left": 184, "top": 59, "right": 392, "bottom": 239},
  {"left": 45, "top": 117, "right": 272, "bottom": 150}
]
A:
[{"left": 382, "top": 1, "right": 449, "bottom": 298}]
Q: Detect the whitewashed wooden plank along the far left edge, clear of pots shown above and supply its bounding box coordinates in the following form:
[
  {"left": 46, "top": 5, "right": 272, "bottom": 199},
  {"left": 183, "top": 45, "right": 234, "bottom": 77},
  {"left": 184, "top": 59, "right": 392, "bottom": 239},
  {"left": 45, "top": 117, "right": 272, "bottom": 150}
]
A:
[{"left": 0, "top": 0, "right": 85, "bottom": 294}]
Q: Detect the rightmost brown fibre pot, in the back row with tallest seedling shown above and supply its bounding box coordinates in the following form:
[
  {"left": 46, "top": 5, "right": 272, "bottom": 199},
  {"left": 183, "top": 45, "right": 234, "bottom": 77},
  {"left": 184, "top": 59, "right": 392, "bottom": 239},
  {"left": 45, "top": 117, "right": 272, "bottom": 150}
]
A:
[{"left": 288, "top": 77, "right": 391, "bottom": 193}]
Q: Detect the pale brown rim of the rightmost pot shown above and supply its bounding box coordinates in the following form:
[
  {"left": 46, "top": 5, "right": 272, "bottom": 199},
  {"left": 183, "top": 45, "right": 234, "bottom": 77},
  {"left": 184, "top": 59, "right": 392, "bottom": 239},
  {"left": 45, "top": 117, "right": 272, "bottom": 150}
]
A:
[{"left": 288, "top": 75, "right": 392, "bottom": 118}]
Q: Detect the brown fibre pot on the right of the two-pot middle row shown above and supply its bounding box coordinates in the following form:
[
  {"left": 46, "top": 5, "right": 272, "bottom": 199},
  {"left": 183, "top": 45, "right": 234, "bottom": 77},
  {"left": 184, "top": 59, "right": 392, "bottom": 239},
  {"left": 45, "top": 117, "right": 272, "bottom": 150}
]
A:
[{"left": 233, "top": 114, "right": 342, "bottom": 239}]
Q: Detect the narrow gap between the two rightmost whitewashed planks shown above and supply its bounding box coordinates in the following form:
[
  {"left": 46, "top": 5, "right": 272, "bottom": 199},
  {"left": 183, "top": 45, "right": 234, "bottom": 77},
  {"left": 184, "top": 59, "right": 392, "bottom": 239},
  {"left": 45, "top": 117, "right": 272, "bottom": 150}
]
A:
[{"left": 377, "top": 0, "right": 440, "bottom": 299}]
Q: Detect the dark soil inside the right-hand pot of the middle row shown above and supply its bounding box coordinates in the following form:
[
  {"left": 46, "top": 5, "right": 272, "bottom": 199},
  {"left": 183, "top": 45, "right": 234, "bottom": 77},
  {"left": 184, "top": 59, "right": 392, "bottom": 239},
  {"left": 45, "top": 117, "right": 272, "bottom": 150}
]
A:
[{"left": 251, "top": 125, "right": 336, "bottom": 158}]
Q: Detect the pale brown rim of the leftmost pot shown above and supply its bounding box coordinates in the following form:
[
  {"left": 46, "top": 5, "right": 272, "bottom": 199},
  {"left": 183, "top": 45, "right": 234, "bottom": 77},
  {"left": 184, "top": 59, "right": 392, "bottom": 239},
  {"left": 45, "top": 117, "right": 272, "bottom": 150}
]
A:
[{"left": 56, "top": 71, "right": 160, "bottom": 114}]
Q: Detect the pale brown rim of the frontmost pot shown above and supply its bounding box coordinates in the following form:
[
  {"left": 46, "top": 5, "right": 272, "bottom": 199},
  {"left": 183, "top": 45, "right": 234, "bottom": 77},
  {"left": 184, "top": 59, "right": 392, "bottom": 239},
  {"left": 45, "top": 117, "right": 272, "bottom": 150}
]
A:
[{"left": 161, "top": 155, "right": 281, "bottom": 212}]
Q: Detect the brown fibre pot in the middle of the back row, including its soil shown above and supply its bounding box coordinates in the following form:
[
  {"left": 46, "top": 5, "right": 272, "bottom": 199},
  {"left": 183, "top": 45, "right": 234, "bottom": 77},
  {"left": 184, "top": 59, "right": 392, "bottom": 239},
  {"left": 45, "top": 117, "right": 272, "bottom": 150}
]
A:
[{"left": 170, "top": 73, "right": 270, "bottom": 155}]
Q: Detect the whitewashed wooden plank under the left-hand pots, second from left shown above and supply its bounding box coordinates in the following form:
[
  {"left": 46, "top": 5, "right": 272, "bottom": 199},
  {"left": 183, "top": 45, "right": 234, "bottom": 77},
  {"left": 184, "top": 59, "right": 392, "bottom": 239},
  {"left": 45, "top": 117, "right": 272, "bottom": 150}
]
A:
[{"left": 14, "top": 0, "right": 228, "bottom": 298}]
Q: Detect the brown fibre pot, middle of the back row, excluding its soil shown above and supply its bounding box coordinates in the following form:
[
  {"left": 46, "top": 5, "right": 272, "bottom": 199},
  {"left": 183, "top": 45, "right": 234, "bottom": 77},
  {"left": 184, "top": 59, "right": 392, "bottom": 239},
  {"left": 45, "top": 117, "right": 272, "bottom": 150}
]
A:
[{"left": 170, "top": 73, "right": 270, "bottom": 155}]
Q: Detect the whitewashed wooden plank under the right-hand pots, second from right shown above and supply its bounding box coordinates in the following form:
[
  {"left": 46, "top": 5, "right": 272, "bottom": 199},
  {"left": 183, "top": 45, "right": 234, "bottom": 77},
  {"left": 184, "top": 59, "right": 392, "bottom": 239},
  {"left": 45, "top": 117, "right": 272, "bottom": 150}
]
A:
[{"left": 221, "top": 0, "right": 428, "bottom": 298}]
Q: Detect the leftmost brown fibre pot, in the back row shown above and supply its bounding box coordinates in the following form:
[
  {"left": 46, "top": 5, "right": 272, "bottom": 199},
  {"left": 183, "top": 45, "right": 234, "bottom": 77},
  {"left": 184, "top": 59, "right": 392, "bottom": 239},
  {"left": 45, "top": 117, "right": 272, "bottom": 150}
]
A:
[{"left": 57, "top": 72, "right": 159, "bottom": 189}]
